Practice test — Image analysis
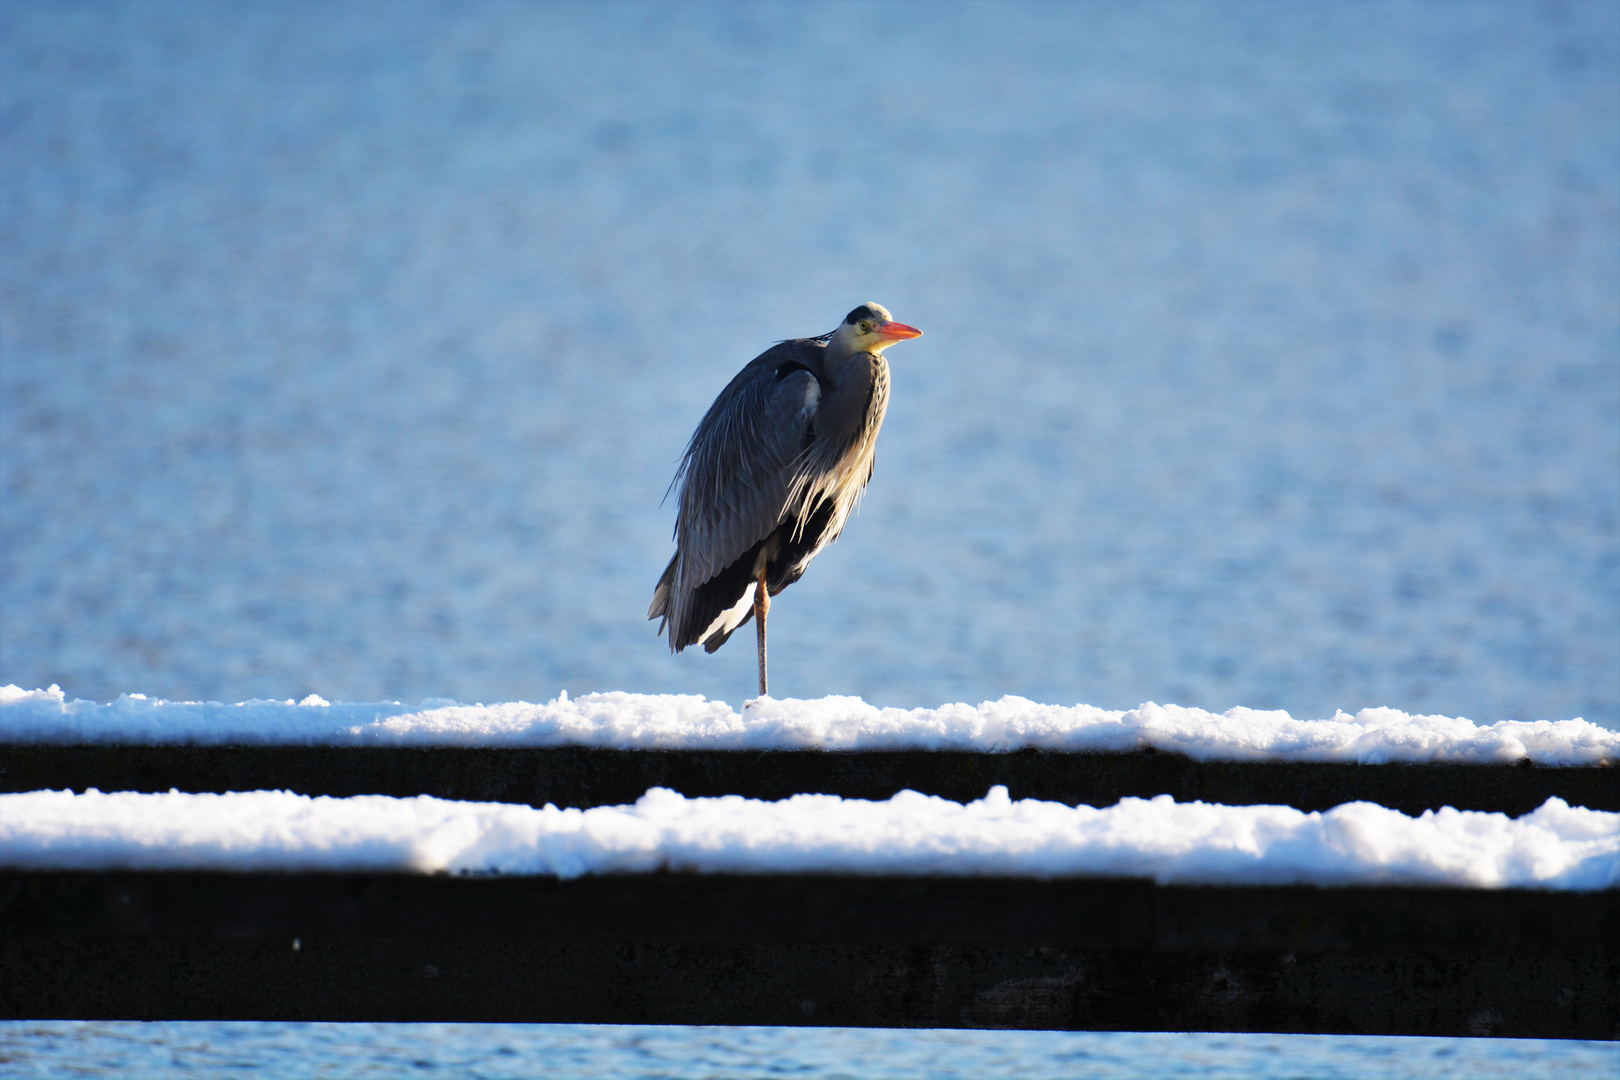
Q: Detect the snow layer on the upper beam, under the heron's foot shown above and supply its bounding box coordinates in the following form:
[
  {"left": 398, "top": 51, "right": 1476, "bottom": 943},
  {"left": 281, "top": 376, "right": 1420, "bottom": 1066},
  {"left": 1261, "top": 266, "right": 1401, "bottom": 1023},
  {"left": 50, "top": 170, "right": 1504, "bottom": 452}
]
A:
[{"left": 0, "top": 687, "right": 1620, "bottom": 766}]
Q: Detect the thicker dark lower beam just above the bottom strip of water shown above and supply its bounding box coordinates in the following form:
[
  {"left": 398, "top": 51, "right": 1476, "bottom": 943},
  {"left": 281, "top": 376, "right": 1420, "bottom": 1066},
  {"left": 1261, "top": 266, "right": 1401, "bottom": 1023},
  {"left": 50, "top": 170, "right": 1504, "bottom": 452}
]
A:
[{"left": 0, "top": 871, "right": 1620, "bottom": 1038}]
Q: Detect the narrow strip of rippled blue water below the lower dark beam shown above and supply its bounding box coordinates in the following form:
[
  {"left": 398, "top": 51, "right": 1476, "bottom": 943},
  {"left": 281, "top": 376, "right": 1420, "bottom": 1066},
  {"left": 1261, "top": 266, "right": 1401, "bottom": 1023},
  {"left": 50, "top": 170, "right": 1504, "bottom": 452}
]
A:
[{"left": 0, "top": 1022, "right": 1620, "bottom": 1080}]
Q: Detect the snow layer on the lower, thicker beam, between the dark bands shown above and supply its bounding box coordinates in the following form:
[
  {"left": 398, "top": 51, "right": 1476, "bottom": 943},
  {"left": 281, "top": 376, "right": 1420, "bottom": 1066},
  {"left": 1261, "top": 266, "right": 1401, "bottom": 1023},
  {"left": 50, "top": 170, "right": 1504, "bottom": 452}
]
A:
[{"left": 0, "top": 785, "right": 1620, "bottom": 891}]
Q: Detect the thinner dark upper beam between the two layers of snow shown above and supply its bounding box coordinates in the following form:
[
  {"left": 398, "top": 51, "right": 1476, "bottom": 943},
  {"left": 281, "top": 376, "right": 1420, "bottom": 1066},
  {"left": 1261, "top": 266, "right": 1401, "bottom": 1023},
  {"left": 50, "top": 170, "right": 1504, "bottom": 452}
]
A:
[{"left": 0, "top": 743, "right": 1620, "bottom": 816}]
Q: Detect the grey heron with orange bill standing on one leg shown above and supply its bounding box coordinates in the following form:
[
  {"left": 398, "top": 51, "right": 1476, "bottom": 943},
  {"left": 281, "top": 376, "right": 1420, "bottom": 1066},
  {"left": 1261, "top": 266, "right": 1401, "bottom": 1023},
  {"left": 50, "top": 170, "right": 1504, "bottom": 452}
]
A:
[{"left": 646, "top": 303, "right": 922, "bottom": 696}]
